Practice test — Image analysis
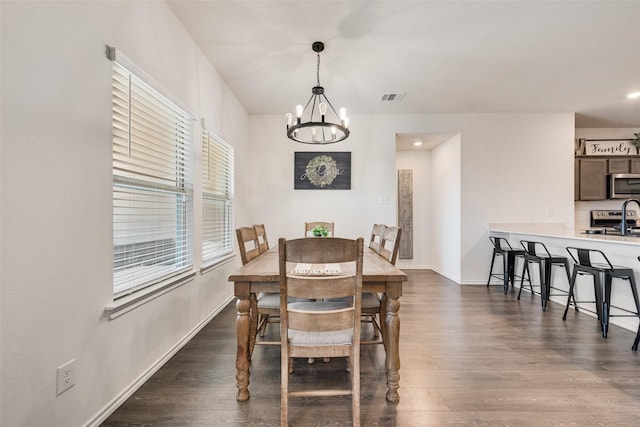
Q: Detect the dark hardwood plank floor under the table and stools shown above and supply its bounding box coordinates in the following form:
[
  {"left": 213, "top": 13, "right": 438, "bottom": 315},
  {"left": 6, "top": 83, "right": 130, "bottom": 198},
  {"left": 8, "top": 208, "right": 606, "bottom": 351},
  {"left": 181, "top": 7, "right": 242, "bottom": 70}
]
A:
[{"left": 103, "top": 270, "right": 640, "bottom": 427}]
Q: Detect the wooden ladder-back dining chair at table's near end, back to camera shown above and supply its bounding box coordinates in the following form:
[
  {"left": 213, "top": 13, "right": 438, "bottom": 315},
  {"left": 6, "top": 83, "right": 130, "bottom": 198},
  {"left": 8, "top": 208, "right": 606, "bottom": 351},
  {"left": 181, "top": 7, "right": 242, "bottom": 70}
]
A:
[{"left": 278, "top": 238, "right": 364, "bottom": 426}]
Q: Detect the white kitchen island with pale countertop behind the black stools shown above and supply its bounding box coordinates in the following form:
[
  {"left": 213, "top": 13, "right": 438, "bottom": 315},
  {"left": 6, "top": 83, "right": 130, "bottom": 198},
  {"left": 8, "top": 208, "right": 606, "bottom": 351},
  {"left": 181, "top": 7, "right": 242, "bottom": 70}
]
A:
[{"left": 488, "top": 223, "right": 640, "bottom": 332}]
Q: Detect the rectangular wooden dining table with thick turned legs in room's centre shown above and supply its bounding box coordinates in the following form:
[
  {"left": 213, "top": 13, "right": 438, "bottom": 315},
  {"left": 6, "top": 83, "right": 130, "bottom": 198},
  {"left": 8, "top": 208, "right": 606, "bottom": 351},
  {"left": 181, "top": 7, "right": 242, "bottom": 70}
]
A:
[{"left": 228, "top": 247, "right": 407, "bottom": 403}]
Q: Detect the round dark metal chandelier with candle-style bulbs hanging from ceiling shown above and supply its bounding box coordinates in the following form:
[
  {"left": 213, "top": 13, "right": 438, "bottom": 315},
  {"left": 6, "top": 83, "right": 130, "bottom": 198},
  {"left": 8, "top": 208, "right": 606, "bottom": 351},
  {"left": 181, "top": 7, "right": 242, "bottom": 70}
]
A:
[{"left": 285, "top": 42, "right": 349, "bottom": 144}]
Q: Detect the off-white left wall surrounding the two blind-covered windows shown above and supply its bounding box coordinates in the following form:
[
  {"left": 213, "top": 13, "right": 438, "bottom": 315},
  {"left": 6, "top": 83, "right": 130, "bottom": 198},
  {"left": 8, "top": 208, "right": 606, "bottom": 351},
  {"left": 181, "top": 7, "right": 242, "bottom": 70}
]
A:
[{"left": 0, "top": 1, "right": 248, "bottom": 426}]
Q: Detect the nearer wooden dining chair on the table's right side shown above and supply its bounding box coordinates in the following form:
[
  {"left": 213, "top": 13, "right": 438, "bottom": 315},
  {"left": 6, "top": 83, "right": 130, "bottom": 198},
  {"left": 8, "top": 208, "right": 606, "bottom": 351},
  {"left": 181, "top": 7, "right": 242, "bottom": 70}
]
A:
[{"left": 362, "top": 225, "right": 402, "bottom": 344}]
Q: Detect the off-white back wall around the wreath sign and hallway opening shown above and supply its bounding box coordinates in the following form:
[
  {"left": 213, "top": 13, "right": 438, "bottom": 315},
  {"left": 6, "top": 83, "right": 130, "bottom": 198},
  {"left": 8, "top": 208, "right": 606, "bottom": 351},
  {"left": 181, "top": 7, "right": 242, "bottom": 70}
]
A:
[{"left": 243, "top": 113, "right": 574, "bottom": 284}]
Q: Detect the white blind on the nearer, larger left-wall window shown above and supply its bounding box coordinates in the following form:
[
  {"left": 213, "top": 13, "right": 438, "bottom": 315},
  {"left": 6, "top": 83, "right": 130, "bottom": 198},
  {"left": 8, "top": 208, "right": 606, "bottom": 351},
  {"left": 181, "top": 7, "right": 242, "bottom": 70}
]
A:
[{"left": 113, "top": 60, "right": 193, "bottom": 298}]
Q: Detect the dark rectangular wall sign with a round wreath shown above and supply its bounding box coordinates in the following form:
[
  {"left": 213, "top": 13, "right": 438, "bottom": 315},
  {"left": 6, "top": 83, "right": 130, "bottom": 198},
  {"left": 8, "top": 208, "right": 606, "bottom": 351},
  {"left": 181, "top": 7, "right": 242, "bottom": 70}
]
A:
[{"left": 293, "top": 151, "right": 351, "bottom": 190}]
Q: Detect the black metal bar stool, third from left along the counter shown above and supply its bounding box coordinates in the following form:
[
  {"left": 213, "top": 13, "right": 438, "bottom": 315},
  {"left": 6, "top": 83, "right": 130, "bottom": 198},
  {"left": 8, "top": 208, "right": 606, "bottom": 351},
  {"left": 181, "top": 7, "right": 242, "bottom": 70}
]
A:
[{"left": 562, "top": 247, "right": 640, "bottom": 351}]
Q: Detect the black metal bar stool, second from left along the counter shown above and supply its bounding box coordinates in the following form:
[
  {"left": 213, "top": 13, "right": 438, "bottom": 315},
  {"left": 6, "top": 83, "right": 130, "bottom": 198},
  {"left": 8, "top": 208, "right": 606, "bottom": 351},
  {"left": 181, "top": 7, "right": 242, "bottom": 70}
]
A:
[{"left": 518, "top": 240, "right": 571, "bottom": 311}]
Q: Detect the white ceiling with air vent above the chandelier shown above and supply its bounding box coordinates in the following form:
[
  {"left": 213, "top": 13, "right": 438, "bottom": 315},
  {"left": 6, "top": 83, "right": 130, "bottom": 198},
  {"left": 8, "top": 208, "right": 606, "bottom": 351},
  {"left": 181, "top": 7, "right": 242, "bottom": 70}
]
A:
[{"left": 168, "top": 0, "right": 640, "bottom": 127}]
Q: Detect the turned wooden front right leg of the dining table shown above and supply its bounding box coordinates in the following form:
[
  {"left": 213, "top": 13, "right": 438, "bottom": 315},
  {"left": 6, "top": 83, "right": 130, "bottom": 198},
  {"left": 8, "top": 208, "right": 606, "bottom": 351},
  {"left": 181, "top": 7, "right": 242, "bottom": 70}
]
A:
[{"left": 383, "top": 296, "right": 400, "bottom": 403}]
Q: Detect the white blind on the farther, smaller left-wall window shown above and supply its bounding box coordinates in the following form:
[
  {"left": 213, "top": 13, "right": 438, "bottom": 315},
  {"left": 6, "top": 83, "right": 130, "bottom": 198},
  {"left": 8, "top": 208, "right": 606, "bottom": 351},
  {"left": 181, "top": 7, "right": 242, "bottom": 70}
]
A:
[{"left": 202, "top": 126, "right": 234, "bottom": 265}]
